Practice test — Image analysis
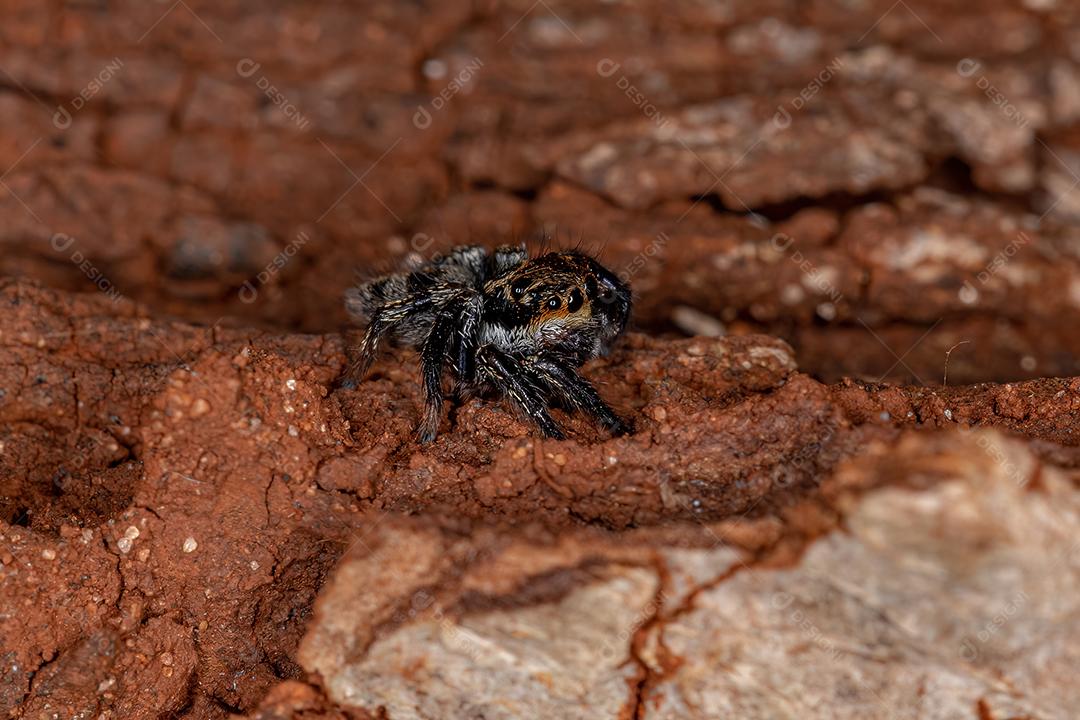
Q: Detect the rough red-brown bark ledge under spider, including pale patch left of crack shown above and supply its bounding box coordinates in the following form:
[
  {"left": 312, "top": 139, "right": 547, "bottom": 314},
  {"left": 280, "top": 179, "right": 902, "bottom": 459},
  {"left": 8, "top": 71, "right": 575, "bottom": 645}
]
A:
[{"left": 0, "top": 282, "right": 1080, "bottom": 717}]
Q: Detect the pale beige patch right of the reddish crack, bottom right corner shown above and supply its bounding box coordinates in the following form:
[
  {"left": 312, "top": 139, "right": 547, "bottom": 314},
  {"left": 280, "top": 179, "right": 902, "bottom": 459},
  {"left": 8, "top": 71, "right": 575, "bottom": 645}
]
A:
[{"left": 644, "top": 433, "right": 1080, "bottom": 718}]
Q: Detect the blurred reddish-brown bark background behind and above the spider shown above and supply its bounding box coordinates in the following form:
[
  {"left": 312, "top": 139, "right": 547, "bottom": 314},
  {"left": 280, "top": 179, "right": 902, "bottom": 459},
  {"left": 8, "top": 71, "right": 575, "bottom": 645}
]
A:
[{"left": 0, "top": 0, "right": 1080, "bottom": 384}]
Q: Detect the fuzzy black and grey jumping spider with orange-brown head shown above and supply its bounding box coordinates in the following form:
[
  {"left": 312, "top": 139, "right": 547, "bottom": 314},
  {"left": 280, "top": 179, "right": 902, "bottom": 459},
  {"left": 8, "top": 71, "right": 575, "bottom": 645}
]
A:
[{"left": 346, "top": 245, "right": 631, "bottom": 443}]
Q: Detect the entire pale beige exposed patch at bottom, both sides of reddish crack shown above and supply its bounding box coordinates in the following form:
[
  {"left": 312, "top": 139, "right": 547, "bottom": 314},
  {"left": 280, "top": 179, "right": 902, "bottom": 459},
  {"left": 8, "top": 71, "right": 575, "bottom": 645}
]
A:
[{"left": 299, "top": 431, "right": 1080, "bottom": 718}]
